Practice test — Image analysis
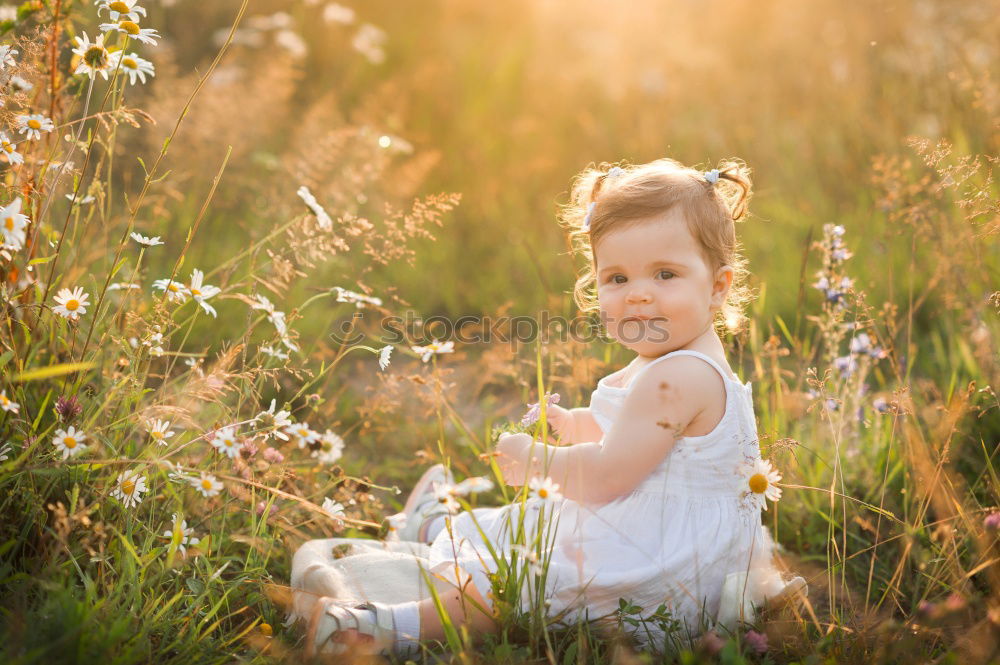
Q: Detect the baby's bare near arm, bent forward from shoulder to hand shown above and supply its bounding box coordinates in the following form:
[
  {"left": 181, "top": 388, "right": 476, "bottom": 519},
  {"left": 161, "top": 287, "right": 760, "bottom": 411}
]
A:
[{"left": 508, "top": 356, "right": 719, "bottom": 504}]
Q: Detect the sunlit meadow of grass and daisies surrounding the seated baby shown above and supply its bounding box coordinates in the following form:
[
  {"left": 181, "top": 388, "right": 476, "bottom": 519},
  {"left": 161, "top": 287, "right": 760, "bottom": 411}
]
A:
[{"left": 0, "top": 0, "right": 1000, "bottom": 665}]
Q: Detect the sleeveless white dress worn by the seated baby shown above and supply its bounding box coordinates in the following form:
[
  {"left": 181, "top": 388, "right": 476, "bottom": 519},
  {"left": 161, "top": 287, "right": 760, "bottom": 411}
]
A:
[{"left": 428, "top": 350, "right": 785, "bottom": 643}]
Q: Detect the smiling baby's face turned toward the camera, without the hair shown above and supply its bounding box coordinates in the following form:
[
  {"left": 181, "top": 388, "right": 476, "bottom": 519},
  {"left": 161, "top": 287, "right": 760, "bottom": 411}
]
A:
[{"left": 594, "top": 209, "right": 731, "bottom": 357}]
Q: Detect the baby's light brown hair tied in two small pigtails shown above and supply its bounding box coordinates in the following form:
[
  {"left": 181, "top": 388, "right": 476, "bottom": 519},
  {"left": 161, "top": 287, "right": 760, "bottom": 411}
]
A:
[{"left": 559, "top": 158, "right": 753, "bottom": 333}]
